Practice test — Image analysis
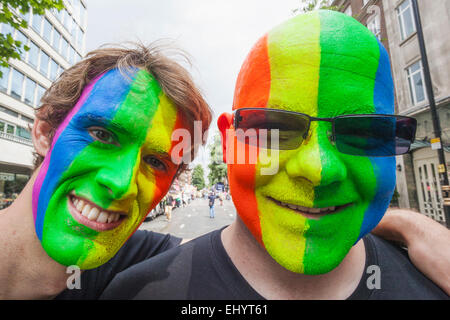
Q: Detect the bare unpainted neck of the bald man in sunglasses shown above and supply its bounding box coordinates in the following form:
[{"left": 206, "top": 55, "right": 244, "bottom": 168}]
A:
[{"left": 222, "top": 216, "right": 365, "bottom": 300}]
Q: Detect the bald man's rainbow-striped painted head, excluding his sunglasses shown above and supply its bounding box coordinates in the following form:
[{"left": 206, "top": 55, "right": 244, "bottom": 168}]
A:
[{"left": 218, "top": 10, "right": 395, "bottom": 274}]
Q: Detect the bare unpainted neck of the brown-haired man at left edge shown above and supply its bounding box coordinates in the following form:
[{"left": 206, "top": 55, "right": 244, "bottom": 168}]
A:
[{"left": 0, "top": 170, "right": 70, "bottom": 299}]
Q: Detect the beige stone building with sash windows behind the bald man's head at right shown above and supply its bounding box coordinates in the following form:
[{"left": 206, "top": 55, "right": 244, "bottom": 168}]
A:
[{"left": 331, "top": 0, "right": 450, "bottom": 223}]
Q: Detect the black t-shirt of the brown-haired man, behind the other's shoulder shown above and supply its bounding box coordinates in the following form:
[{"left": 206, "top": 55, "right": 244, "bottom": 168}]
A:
[{"left": 55, "top": 230, "right": 181, "bottom": 300}]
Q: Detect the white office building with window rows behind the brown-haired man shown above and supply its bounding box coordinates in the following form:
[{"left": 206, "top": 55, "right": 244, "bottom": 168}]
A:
[{"left": 0, "top": 0, "right": 87, "bottom": 208}]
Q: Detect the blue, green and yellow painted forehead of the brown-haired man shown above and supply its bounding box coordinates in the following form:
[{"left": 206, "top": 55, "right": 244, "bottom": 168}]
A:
[{"left": 73, "top": 69, "right": 176, "bottom": 146}]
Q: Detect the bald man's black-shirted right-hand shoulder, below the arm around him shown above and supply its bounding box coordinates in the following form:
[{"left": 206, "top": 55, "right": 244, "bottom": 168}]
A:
[{"left": 364, "top": 234, "right": 449, "bottom": 299}]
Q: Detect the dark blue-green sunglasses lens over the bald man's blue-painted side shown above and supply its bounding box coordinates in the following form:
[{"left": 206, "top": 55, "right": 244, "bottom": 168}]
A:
[{"left": 334, "top": 116, "right": 415, "bottom": 157}]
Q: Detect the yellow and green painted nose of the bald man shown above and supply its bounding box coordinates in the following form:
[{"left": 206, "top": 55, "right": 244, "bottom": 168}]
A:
[{"left": 286, "top": 122, "right": 347, "bottom": 187}]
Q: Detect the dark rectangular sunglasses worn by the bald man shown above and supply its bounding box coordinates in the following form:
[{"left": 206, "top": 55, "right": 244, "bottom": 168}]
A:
[{"left": 234, "top": 108, "right": 417, "bottom": 157}]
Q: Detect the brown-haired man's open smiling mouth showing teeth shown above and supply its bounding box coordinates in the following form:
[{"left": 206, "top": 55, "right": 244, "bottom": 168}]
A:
[{"left": 68, "top": 194, "right": 127, "bottom": 231}]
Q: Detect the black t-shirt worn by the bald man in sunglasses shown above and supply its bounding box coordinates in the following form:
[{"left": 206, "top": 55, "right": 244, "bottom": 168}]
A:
[{"left": 101, "top": 226, "right": 449, "bottom": 300}]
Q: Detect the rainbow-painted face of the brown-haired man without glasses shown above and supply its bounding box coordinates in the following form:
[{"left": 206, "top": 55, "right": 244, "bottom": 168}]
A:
[{"left": 33, "top": 69, "right": 182, "bottom": 269}]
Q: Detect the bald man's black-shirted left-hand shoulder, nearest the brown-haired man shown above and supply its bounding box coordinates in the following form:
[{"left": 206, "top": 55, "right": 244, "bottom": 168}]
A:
[{"left": 101, "top": 230, "right": 262, "bottom": 300}]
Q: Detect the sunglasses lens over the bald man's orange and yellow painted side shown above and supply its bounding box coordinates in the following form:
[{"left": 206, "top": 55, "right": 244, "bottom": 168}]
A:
[{"left": 235, "top": 108, "right": 309, "bottom": 150}]
